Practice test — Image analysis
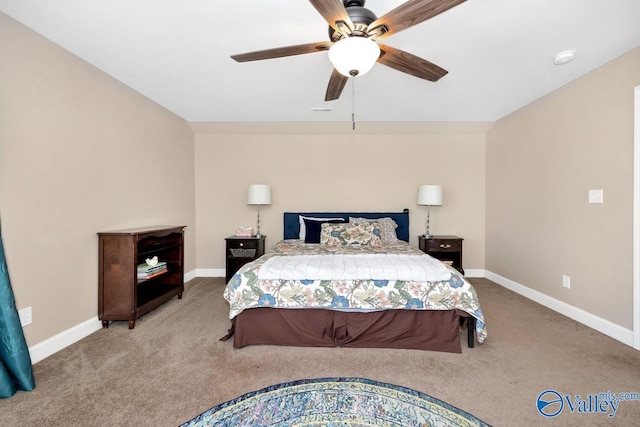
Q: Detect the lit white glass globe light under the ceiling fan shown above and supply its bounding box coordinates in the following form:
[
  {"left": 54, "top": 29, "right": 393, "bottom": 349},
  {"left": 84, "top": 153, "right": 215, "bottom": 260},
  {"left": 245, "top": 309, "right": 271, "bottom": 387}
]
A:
[{"left": 329, "top": 36, "right": 380, "bottom": 77}]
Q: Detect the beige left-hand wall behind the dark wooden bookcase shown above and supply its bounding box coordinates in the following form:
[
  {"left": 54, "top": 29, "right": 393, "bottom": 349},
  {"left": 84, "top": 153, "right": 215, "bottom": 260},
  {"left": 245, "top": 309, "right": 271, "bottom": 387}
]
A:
[{"left": 0, "top": 13, "right": 195, "bottom": 345}]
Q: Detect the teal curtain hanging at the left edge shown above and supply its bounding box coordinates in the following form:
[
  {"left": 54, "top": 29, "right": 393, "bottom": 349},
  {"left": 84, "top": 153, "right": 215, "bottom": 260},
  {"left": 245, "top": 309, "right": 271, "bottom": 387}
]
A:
[{"left": 0, "top": 228, "right": 36, "bottom": 398}]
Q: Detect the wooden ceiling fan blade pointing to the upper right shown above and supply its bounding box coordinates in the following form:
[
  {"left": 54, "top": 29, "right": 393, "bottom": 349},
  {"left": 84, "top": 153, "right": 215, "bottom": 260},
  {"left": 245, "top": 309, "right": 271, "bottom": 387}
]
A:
[{"left": 367, "top": 0, "right": 466, "bottom": 40}]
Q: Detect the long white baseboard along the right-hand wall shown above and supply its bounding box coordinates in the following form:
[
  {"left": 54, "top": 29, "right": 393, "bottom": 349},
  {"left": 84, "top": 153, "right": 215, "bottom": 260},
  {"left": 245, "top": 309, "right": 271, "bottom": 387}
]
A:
[{"left": 478, "top": 271, "right": 634, "bottom": 347}]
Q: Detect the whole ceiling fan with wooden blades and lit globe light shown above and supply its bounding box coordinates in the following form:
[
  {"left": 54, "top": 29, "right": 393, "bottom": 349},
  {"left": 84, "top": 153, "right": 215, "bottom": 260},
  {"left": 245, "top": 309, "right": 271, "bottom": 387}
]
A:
[{"left": 231, "top": 0, "right": 466, "bottom": 101}]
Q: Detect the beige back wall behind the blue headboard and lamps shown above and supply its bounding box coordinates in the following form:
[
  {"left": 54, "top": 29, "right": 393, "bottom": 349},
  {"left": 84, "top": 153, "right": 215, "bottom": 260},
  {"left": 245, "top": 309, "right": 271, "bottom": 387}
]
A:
[{"left": 196, "top": 125, "right": 485, "bottom": 269}]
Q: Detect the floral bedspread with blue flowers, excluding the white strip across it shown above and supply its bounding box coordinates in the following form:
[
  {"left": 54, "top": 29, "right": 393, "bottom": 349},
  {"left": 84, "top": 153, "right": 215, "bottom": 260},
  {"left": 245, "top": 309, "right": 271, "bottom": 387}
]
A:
[{"left": 224, "top": 240, "right": 487, "bottom": 343}]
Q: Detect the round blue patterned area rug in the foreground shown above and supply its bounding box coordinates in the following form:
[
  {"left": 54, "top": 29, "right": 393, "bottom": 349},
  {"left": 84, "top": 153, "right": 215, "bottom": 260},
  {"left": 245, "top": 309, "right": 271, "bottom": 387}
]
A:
[{"left": 182, "top": 378, "right": 488, "bottom": 427}]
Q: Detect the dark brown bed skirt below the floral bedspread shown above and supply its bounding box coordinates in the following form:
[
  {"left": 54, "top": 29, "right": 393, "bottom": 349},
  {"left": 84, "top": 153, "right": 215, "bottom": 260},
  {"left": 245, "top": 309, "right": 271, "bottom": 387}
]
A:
[{"left": 225, "top": 307, "right": 469, "bottom": 353}]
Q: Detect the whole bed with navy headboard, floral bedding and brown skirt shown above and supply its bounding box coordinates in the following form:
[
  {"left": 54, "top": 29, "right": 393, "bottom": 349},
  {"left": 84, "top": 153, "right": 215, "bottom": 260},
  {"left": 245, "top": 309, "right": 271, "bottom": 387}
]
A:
[{"left": 223, "top": 209, "right": 487, "bottom": 353}]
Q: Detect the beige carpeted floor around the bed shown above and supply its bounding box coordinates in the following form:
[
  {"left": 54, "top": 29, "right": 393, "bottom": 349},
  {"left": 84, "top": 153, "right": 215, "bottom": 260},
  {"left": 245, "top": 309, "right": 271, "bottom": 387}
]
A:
[{"left": 0, "top": 278, "right": 640, "bottom": 426}]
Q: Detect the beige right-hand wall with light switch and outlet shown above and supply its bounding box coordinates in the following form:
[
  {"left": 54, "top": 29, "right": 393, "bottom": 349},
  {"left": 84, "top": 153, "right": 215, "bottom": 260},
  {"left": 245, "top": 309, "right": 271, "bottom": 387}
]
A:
[{"left": 486, "top": 48, "right": 640, "bottom": 329}]
